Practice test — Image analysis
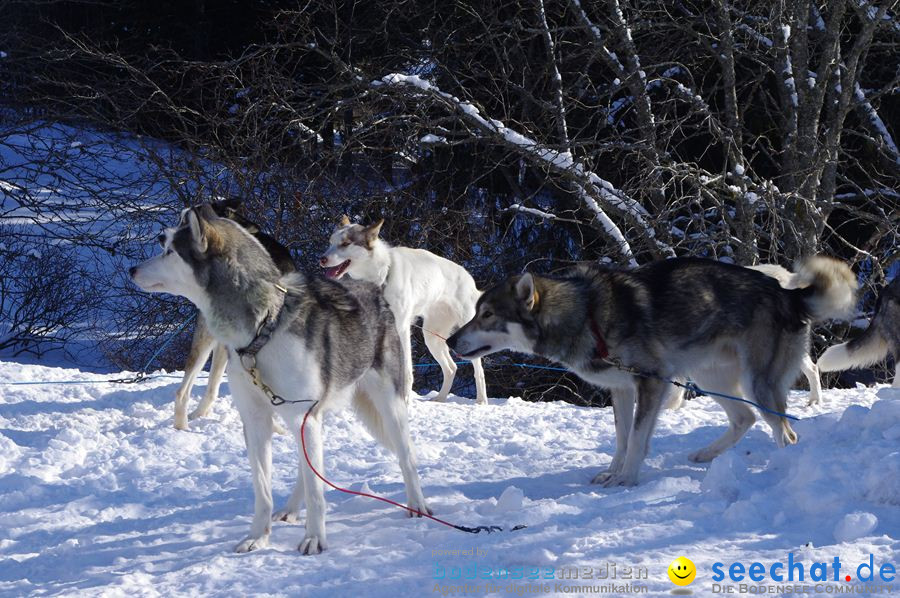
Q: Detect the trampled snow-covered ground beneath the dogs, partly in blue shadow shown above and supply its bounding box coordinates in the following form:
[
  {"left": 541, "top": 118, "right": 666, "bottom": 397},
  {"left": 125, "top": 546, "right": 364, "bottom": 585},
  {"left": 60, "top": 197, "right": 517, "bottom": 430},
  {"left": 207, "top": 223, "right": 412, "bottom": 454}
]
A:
[{"left": 0, "top": 363, "right": 900, "bottom": 598}]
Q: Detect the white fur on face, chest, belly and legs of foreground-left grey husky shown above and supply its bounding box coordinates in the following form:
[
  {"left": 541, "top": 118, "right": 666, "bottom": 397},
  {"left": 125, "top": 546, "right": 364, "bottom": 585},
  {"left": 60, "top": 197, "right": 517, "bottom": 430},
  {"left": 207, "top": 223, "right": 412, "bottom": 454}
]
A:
[{"left": 132, "top": 223, "right": 431, "bottom": 554}]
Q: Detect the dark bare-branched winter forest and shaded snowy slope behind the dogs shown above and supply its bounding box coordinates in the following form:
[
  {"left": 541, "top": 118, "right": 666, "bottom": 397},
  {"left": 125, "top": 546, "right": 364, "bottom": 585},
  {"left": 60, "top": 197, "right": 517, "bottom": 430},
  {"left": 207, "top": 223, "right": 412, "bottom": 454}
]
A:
[{"left": 0, "top": 0, "right": 900, "bottom": 402}]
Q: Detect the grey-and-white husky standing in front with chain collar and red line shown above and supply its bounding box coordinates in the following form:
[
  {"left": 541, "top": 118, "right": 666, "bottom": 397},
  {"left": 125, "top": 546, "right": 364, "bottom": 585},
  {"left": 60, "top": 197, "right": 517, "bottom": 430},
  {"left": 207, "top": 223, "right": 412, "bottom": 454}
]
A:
[{"left": 130, "top": 204, "right": 430, "bottom": 554}]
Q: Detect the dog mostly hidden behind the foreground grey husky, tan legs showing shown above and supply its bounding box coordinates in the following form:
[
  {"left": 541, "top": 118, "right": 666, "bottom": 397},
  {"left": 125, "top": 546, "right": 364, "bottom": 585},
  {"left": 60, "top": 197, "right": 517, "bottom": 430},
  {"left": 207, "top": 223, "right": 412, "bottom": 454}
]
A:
[{"left": 171, "top": 198, "right": 297, "bottom": 430}]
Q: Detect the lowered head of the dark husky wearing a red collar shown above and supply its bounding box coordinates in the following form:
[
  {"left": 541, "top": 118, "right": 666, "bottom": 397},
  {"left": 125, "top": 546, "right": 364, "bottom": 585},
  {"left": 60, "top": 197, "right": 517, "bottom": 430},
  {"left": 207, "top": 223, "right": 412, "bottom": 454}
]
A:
[{"left": 447, "top": 274, "right": 541, "bottom": 359}]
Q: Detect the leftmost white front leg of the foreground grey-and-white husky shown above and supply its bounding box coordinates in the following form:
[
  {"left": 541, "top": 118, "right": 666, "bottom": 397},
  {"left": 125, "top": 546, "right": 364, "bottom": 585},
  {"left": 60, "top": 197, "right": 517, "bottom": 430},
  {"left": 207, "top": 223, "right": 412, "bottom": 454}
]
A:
[{"left": 232, "top": 378, "right": 272, "bottom": 552}]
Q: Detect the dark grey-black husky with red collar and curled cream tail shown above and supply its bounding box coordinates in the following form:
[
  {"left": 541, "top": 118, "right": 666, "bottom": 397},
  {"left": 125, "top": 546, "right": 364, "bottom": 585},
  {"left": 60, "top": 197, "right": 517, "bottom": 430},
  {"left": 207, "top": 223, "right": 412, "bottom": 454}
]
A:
[{"left": 449, "top": 257, "right": 856, "bottom": 486}]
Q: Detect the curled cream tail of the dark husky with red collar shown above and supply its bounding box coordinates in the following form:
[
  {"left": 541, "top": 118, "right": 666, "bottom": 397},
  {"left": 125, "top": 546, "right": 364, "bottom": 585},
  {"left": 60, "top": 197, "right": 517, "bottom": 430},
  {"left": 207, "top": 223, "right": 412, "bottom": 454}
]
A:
[{"left": 795, "top": 255, "right": 856, "bottom": 322}]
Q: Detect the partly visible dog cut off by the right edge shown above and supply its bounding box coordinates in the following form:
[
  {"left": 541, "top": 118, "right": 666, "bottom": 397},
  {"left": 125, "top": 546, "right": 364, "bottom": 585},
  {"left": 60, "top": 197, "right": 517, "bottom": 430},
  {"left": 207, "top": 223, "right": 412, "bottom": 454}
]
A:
[{"left": 819, "top": 276, "right": 900, "bottom": 388}]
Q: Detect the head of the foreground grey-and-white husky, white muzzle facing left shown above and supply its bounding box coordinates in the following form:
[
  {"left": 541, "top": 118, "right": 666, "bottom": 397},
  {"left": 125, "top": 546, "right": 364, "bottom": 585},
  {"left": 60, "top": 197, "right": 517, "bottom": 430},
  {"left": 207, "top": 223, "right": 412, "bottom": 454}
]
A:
[{"left": 128, "top": 204, "right": 278, "bottom": 306}]
